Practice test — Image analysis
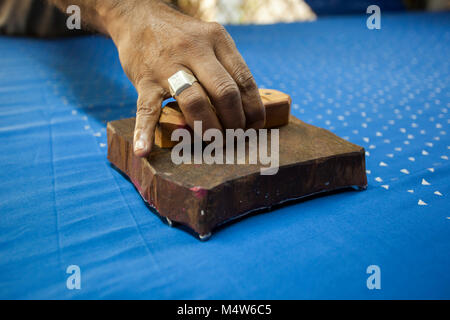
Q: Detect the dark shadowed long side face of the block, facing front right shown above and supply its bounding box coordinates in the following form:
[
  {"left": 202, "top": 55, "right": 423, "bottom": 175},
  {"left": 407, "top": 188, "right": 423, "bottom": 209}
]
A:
[{"left": 205, "top": 148, "right": 367, "bottom": 234}]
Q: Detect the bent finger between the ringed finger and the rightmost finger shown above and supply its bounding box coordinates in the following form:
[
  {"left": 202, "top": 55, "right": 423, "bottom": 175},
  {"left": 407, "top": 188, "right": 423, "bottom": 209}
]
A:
[{"left": 185, "top": 52, "right": 245, "bottom": 129}]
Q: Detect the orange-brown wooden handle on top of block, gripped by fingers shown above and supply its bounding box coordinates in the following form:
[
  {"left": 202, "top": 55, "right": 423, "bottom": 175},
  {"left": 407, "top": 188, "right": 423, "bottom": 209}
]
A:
[{"left": 155, "top": 89, "right": 291, "bottom": 148}]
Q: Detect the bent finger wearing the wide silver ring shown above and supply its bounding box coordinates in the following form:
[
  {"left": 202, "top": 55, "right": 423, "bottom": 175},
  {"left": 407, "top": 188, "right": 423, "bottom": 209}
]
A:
[{"left": 164, "top": 66, "right": 222, "bottom": 132}]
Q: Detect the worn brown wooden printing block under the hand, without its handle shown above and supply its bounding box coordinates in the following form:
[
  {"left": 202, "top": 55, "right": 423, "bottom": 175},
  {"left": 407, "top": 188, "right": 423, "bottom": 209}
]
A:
[{"left": 107, "top": 94, "right": 367, "bottom": 239}]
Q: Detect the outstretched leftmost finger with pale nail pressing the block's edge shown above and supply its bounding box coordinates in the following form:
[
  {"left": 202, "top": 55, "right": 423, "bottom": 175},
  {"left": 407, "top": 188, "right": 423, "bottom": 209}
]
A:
[{"left": 133, "top": 81, "right": 164, "bottom": 157}]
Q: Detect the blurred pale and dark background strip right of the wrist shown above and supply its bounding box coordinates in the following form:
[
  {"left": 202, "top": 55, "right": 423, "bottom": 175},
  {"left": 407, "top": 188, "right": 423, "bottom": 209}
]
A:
[{"left": 170, "top": 0, "right": 450, "bottom": 24}]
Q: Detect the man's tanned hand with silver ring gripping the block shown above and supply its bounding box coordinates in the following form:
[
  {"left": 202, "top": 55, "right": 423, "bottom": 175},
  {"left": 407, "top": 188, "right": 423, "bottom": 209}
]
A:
[{"left": 105, "top": 1, "right": 265, "bottom": 157}]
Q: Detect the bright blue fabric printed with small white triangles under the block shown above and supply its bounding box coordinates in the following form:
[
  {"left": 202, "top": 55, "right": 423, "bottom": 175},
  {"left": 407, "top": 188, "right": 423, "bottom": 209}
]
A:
[{"left": 0, "top": 14, "right": 450, "bottom": 299}]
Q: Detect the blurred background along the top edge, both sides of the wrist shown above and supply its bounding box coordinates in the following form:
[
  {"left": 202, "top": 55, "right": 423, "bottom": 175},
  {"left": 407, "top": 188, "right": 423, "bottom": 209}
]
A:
[{"left": 0, "top": 0, "right": 450, "bottom": 37}]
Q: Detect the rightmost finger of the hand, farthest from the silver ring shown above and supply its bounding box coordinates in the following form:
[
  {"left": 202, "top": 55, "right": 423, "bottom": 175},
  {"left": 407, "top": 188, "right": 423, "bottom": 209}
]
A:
[{"left": 214, "top": 25, "right": 265, "bottom": 129}]
